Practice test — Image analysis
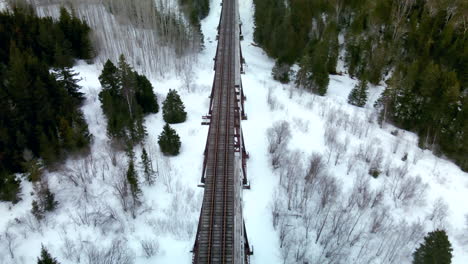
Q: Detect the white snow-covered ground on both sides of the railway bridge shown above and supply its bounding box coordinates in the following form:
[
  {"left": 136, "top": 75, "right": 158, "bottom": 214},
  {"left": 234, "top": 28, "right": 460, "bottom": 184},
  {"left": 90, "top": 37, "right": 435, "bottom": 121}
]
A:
[{"left": 0, "top": 0, "right": 468, "bottom": 264}]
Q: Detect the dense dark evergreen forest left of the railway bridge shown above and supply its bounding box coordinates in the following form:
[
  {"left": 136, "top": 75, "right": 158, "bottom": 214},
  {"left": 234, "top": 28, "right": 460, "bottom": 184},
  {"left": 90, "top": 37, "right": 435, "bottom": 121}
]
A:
[{"left": 0, "top": 8, "right": 92, "bottom": 202}]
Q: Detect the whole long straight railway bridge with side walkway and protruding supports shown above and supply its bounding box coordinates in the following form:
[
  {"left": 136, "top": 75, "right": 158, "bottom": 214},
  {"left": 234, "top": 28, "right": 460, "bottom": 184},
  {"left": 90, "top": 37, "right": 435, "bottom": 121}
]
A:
[{"left": 193, "top": 0, "right": 253, "bottom": 264}]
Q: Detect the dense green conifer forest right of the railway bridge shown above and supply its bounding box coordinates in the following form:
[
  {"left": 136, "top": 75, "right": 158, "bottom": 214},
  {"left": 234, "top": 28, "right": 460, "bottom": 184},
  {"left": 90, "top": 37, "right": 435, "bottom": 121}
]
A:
[{"left": 254, "top": 0, "right": 468, "bottom": 171}]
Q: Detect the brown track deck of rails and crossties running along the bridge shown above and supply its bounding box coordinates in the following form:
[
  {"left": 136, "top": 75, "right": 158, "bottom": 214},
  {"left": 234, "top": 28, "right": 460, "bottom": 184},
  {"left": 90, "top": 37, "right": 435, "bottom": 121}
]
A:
[{"left": 194, "top": 0, "right": 241, "bottom": 264}]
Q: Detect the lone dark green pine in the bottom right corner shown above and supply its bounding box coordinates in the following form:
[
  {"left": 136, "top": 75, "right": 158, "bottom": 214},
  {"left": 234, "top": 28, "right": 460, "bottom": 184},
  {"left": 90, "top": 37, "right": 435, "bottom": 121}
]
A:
[{"left": 413, "top": 230, "right": 453, "bottom": 264}]
